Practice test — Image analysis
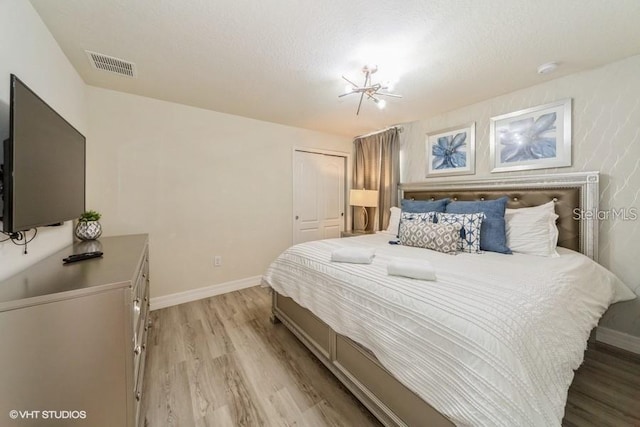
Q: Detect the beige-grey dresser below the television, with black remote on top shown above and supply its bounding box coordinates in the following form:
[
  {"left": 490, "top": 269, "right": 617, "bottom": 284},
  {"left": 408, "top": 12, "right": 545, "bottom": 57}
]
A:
[{"left": 0, "top": 235, "right": 150, "bottom": 427}]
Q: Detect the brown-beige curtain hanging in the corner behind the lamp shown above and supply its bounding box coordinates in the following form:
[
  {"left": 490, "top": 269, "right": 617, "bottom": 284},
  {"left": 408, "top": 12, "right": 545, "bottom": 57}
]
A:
[{"left": 353, "top": 128, "right": 400, "bottom": 231}]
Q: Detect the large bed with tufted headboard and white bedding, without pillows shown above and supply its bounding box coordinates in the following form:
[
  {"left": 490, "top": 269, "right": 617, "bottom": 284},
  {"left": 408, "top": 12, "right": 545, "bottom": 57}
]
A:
[{"left": 263, "top": 173, "right": 630, "bottom": 426}]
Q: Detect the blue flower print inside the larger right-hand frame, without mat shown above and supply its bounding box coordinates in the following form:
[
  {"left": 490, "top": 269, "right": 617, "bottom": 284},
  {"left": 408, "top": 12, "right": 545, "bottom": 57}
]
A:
[{"left": 498, "top": 112, "right": 556, "bottom": 163}]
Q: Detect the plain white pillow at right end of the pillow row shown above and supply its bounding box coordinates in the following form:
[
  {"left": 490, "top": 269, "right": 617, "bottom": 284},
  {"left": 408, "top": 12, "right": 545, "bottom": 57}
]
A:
[{"left": 504, "top": 202, "right": 560, "bottom": 257}]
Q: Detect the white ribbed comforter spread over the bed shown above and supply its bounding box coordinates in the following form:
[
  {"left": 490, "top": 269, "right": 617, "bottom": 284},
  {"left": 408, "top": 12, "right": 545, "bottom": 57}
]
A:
[{"left": 264, "top": 234, "right": 635, "bottom": 427}]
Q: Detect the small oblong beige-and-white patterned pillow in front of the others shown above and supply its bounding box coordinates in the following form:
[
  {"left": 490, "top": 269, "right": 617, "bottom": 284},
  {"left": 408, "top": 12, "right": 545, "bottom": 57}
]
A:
[{"left": 400, "top": 219, "right": 460, "bottom": 255}]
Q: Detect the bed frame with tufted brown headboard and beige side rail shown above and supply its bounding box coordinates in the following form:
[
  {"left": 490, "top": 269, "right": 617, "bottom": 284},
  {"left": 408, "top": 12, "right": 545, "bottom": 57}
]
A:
[{"left": 271, "top": 172, "right": 599, "bottom": 427}]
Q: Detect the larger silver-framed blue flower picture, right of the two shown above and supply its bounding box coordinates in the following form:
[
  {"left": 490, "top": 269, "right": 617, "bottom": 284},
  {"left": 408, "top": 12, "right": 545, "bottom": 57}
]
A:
[{"left": 489, "top": 99, "right": 571, "bottom": 172}]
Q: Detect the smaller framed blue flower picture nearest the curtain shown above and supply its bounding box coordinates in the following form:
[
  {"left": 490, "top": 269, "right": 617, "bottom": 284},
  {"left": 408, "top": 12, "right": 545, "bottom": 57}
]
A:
[{"left": 427, "top": 122, "right": 476, "bottom": 178}]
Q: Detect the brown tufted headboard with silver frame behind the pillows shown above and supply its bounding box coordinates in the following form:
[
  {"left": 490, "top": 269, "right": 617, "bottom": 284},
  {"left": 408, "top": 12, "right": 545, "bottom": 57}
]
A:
[{"left": 399, "top": 172, "right": 599, "bottom": 261}]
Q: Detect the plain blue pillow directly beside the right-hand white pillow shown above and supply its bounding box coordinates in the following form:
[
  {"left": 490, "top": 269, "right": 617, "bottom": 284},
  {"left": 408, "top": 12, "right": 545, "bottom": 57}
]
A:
[{"left": 445, "top": 196, "right": 511, "bottom": 254}]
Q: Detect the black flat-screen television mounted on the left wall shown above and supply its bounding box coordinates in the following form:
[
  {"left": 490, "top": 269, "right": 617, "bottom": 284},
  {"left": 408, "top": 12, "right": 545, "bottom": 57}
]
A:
[{"left": 2, "top": 74, "right": 86, "bottom": 233}]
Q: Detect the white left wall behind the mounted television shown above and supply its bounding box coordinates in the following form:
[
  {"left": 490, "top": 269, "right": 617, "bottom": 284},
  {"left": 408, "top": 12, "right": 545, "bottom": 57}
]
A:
[{"left": 0, "top": 0, "right": 86, "bottom": 280}]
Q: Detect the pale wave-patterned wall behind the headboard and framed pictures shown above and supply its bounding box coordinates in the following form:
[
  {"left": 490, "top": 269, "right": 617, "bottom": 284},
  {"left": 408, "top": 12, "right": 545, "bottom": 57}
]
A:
[{"left": 401, "top": 56, "right": 640, "bottom": 336}]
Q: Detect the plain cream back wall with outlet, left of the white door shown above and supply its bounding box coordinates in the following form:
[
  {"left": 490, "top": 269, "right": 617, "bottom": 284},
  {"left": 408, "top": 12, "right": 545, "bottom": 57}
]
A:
[{"left": 87, "top": 87, "right": 352, "bottom": 297}]
